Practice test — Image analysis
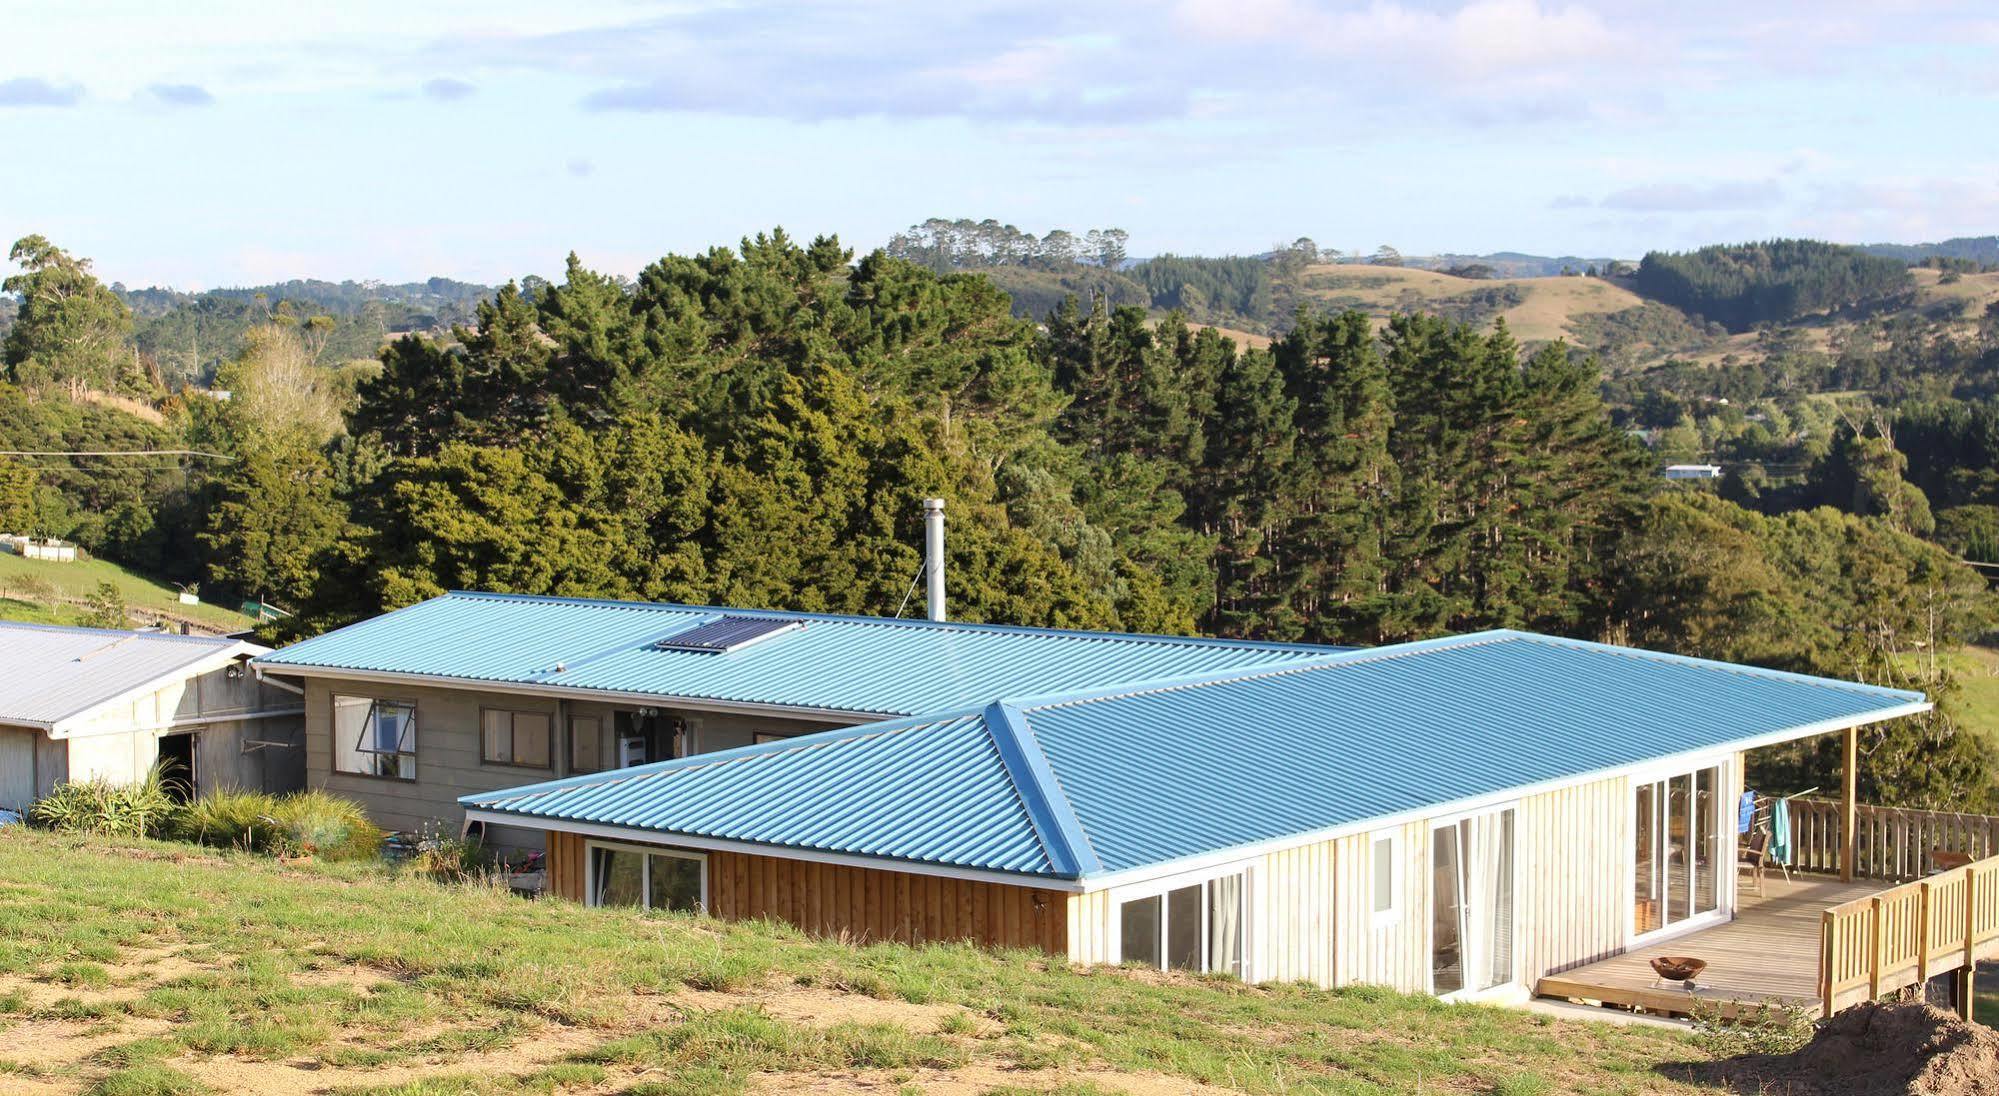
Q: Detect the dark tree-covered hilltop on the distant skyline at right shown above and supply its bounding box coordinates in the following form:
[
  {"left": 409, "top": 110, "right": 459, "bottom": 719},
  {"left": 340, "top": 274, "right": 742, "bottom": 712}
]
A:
[{"left": 1633, "top": 240, "right": 1911, "bottom": 332}]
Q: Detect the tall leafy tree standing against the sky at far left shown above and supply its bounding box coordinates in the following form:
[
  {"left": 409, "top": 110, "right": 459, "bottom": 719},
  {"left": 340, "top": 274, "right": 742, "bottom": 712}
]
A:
[{"left": 0, "top": 236, "right": 152, "bottom": 394}]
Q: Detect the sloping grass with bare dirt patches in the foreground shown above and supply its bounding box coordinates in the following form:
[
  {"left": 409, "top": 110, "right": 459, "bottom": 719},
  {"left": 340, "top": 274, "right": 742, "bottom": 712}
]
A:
[{"left": 0, "top": 828, "right": 1697, "bottom": 1096}]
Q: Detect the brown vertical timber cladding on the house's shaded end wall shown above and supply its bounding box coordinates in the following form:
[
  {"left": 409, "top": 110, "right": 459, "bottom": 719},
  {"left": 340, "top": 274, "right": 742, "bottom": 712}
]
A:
[{"left": 548, "top": 832, "right": 1069, "bottom": 956}]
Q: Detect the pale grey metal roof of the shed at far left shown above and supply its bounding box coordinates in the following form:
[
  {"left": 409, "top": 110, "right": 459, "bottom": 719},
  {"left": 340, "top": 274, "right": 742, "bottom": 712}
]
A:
[{"left": 0, "top": 622, "right": 262, "bottom": 726}]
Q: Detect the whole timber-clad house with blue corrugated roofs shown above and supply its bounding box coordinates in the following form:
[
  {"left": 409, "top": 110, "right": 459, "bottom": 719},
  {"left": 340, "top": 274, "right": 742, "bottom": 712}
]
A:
[{"left": 256, "top": 594, "right": 1999, "bottom": 1012}]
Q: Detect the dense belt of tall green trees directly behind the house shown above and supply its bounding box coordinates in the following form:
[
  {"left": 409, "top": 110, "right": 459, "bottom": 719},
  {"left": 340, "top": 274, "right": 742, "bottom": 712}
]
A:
[{"left": 0, "top": 232, "right": 1983, "bottom": 802}]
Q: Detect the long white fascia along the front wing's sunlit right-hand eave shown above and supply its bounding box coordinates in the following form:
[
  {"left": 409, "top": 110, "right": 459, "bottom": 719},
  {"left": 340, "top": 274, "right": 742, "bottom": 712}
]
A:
[{"left": 1081, "top": 702, "right": 1935, "bottom": 890}]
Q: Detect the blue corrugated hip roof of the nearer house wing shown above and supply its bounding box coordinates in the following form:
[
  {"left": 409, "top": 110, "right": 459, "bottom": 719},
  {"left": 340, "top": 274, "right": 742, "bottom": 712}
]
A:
[{"left": 460, "top": 632, "right": 1923, "bottom": 878}]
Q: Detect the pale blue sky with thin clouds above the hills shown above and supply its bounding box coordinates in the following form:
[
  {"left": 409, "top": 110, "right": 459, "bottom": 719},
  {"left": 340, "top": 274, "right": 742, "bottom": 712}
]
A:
[{"left": 0, "top": 0, "right": 1999, "bottom": 288}]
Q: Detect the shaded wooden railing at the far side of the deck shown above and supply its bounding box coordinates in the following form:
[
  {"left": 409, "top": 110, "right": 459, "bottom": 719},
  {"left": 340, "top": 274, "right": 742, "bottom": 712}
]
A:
[{"left": 1791, "top": 798, "right": 1999, "bottom": 882}]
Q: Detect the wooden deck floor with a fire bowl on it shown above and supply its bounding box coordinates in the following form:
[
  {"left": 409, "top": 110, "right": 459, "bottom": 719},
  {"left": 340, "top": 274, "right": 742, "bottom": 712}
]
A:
[{"left": 1535, "top": 872, "right": 1881, "bottom": 1014}]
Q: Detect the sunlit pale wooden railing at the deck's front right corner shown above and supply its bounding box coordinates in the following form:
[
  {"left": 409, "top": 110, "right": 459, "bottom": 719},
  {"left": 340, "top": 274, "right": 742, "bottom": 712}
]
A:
[{"left": 1819, "top": 856, "right": 1999, "bottom": 1016}]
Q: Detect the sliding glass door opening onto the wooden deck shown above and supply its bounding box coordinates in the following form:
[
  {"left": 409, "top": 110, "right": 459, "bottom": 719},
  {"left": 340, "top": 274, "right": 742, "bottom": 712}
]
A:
[{"left": 1631, "top": 766, "right": 1725, "bottom": 936}]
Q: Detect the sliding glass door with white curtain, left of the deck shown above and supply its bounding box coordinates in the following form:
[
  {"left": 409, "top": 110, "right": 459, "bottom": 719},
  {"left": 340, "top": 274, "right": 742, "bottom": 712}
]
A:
[{"left": 1429, "top": 808, "right": 1515, "bottom": 996}]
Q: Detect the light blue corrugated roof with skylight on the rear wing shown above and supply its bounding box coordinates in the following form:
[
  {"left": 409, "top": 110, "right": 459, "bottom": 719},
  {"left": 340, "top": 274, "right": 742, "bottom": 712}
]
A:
[{"left": 258, "top": 594, "right": 1339, "bottom": 716}]
